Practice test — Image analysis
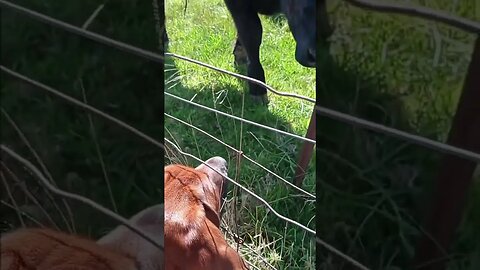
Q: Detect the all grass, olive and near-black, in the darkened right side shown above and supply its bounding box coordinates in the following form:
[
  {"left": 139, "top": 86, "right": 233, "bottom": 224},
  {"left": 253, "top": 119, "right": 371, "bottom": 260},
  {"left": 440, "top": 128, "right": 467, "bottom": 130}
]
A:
[{"left": 316, "top": 0, "right": 480, "bottom": 269}]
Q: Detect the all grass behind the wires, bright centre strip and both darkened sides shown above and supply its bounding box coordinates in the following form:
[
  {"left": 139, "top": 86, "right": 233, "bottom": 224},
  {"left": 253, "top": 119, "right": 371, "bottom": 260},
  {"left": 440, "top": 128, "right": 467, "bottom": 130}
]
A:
[{"left": 0, "top": 0, "right": 480, "bottom": 270}]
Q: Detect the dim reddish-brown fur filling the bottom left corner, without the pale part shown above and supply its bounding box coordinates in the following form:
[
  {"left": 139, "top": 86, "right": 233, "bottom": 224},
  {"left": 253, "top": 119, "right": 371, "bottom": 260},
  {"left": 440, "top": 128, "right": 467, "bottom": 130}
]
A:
[{"left": 1, "top": 229, "right": 138, "bottom": 270}]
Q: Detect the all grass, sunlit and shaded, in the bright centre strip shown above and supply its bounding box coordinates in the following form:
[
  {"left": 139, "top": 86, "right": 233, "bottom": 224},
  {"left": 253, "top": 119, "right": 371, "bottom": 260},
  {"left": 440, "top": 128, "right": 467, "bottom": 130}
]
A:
[{"left": 165, "top": 0, "right": 315, "bottom": 269}]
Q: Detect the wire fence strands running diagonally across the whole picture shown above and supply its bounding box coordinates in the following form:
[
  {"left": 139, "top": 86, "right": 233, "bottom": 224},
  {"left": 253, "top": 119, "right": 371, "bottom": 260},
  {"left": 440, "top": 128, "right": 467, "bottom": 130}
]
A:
[{"left": 0, "top": 0, "right": 480, "bottom": 269}]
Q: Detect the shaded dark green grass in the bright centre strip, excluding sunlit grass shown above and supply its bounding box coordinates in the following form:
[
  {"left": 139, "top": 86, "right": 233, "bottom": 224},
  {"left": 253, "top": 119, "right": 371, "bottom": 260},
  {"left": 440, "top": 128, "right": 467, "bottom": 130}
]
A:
[{"left": 165, "top": 59, "right": 314, "bottom": 269}]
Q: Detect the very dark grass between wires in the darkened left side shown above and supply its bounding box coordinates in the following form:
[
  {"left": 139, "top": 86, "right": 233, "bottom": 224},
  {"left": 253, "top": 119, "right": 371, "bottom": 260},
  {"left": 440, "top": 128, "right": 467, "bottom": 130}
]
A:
[{"left": 0, "top": 0, "right": 164, "bottom": 237}]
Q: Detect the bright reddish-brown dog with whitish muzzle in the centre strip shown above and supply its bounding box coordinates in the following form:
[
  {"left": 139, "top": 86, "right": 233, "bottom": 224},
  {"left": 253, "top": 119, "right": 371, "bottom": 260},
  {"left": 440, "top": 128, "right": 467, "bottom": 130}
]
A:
[{"left": 165, "top": 157, "right": 249, "bottom": 270}]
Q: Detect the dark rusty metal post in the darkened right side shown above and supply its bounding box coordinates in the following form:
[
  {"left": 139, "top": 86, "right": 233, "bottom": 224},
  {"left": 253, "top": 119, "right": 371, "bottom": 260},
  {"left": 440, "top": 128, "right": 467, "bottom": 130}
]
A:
[{"left": 413, "top": 36, "right": 480, "bottom": 270}]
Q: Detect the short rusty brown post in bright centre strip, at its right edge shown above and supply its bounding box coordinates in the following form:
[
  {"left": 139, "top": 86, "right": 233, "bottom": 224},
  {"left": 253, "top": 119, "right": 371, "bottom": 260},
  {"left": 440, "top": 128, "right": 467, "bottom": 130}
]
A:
[{"left": 295, "top": 108, "right": 316, "bottom": 187}]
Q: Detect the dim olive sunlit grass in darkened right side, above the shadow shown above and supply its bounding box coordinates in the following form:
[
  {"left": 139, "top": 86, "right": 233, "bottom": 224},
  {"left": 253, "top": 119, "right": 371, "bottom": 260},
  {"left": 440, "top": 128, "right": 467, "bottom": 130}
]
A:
[{"left": 330, "top": 0, "right": 480, "bottom": 140}]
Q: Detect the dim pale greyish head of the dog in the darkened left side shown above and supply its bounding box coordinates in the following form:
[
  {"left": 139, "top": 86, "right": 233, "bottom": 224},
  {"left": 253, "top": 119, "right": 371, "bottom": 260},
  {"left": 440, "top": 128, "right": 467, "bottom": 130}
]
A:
[{"left": 97, "top": 204, "right": 164, "bottom": 270}]
